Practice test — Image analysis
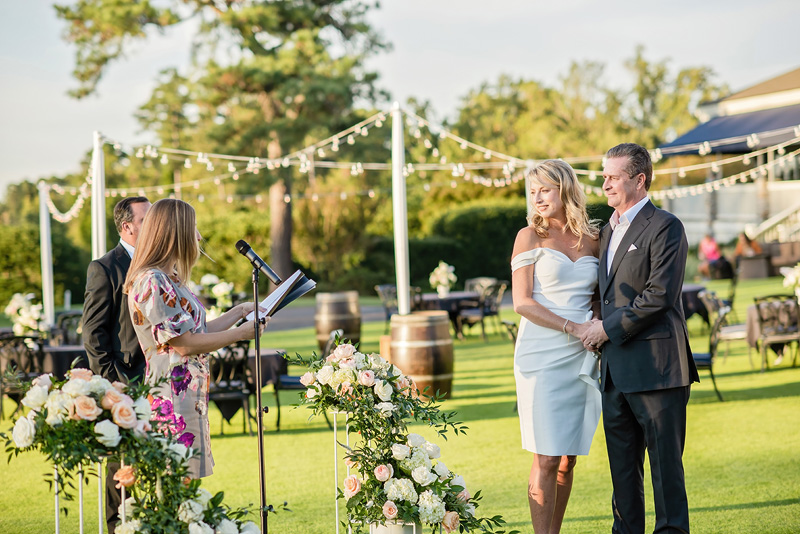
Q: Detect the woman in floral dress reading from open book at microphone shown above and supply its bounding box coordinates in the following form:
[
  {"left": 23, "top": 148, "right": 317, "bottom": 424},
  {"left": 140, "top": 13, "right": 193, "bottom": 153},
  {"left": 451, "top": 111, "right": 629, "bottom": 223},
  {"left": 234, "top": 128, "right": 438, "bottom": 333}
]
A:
[{"left": 125, "top": 199, "right": 264, "bottom": 478}]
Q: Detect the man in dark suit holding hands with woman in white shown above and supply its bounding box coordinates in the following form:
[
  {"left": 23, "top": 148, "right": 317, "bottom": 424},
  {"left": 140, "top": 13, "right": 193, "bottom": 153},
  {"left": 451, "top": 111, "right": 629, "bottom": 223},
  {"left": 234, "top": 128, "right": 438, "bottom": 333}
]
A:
[{"left": 581, "top": 143, "right": 698, "bottom": 534}]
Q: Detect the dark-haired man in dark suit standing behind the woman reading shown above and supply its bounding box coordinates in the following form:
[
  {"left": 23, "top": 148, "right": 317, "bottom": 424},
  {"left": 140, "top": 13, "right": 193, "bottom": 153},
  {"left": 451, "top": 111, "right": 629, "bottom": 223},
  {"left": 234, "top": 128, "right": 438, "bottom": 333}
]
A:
[{"left": 83, "top": 197, "right": 150, "bottom": 533}]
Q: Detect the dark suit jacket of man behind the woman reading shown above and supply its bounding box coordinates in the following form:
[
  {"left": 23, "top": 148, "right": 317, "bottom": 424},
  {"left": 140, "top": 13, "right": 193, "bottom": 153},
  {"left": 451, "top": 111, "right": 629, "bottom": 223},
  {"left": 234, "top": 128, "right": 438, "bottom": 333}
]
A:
[{"left": 83, "top": 244, "right": 145, "bottom": 382}]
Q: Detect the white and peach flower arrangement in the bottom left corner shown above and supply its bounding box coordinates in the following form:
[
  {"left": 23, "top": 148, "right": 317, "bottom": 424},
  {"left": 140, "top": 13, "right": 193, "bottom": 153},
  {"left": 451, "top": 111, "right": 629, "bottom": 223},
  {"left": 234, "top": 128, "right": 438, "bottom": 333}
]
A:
[{"left": 0, "top": 369, "right": 260, "bottom": 534}]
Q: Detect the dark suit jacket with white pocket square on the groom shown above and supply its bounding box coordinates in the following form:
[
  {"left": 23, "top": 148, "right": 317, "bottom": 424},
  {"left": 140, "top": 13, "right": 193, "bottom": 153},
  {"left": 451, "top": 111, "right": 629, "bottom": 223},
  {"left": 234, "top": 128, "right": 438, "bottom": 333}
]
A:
[{"left": 599, "top": 202, "right": 698, "bottom": 393}]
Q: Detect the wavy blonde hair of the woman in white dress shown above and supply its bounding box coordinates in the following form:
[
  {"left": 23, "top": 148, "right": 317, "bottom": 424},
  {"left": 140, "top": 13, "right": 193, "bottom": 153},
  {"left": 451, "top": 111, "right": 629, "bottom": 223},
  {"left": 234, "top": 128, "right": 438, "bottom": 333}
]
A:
[{"left": 527, "top": 159, "right": 600, "bottom": 249}]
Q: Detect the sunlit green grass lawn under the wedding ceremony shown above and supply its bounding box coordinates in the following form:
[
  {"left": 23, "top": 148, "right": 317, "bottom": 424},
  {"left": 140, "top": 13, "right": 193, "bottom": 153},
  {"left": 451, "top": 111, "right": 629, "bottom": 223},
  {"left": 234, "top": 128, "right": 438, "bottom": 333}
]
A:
[{"left": 0, "top": 278, "right": 800, "bottom": 534}]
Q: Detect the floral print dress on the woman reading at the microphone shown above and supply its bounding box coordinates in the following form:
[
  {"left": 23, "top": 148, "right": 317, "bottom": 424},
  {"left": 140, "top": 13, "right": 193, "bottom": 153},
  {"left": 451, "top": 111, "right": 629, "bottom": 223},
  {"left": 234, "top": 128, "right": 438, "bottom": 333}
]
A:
[{"left": 128, "top": 269, "right": 214, "bottom": 478}]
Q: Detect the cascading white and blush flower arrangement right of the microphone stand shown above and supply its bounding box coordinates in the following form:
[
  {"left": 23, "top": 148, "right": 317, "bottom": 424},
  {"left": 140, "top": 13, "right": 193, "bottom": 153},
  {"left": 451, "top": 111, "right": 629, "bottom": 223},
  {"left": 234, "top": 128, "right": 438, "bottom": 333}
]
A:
[{"left": 289, "top": 344, "right": 504, "bottom": 533}]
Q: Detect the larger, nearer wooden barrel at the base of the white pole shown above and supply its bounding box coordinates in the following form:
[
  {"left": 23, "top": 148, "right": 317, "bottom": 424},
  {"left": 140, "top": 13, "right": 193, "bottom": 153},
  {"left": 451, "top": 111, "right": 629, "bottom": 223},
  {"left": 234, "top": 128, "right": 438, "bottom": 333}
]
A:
[{"left": 390, "top": 311, "right": 453, "bottom": 398}]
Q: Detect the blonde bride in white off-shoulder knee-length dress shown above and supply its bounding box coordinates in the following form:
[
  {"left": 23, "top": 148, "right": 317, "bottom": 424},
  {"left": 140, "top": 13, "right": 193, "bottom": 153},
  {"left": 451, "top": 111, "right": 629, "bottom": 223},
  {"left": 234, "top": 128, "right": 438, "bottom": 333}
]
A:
[{"left": 511, "top": 160, "right": 601, "bottom": 534}]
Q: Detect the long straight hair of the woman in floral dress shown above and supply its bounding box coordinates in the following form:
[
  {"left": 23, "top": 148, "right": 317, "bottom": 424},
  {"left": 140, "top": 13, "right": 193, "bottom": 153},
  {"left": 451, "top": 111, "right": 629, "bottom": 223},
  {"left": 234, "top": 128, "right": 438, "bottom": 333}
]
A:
[{"left": 125, "top": 198, "right": 200, "bottom": 293}]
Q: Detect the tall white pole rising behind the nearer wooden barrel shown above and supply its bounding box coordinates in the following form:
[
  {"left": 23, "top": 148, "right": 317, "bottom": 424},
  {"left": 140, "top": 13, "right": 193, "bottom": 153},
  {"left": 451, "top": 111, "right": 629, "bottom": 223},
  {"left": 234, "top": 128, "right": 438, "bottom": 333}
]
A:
[{"left": 392, "top": 102, "right": 411, "bottom": 315}]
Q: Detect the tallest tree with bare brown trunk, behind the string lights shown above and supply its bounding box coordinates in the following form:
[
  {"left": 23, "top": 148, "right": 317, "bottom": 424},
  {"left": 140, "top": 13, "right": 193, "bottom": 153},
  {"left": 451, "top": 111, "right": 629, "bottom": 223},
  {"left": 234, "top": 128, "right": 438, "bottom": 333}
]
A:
[{"left": 56, "top": 0, "right": 384, "bottom": 282}]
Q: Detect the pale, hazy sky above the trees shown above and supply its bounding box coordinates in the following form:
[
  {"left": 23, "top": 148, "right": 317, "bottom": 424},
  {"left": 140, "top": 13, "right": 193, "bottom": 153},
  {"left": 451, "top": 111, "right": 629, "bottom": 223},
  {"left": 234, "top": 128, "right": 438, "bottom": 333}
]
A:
[{"left": 0, "top": 0, "right": 800, "bottom": 192}]
